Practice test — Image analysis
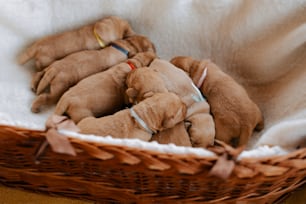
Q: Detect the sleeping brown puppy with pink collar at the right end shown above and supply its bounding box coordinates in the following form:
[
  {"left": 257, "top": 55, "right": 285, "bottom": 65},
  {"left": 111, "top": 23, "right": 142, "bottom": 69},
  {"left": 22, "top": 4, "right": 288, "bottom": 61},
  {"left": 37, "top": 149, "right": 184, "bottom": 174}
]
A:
[{"left": 171, "top": 56, "right": 264, "bottom": 146}]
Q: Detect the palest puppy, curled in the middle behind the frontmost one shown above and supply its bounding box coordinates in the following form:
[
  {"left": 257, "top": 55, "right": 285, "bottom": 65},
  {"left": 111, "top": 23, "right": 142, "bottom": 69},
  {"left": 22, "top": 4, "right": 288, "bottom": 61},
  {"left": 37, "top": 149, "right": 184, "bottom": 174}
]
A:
[{"left": 126, "top": 59, "right": 215, "bottom": 147}]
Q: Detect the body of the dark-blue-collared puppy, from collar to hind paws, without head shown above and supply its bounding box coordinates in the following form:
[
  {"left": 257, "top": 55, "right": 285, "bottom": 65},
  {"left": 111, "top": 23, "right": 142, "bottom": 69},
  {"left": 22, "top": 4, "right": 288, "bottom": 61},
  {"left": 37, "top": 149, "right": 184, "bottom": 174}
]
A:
[{"left": 32, "top": 47, "right": 127, "bottom": 112}]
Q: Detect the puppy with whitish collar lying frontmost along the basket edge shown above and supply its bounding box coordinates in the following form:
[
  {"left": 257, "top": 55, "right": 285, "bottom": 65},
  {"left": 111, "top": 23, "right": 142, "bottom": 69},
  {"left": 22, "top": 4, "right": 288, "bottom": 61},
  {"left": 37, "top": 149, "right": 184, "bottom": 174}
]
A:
[{"left": 78, "top": 93, "right": 186, "bottom": 141}]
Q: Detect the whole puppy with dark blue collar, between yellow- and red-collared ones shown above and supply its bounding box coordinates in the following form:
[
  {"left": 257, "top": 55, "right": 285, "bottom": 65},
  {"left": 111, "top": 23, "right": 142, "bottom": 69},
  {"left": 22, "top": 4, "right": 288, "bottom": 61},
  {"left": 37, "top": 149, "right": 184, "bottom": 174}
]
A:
[{"left": 32, "top": 35, "right": 155, "bottom": 113}]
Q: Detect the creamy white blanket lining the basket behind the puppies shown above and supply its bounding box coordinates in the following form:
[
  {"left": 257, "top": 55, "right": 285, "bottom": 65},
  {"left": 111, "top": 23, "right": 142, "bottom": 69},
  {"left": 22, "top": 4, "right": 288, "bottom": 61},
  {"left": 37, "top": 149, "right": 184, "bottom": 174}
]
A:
[{"left": 0, "top": 0, "right": 306, "bottom": 152}]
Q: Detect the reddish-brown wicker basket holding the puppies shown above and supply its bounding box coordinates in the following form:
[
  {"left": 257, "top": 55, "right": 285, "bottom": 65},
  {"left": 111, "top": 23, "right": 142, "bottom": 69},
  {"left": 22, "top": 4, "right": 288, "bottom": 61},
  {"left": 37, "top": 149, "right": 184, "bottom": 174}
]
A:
[{"left": 0, "top": 125, "right": 306, "bottom": 203}]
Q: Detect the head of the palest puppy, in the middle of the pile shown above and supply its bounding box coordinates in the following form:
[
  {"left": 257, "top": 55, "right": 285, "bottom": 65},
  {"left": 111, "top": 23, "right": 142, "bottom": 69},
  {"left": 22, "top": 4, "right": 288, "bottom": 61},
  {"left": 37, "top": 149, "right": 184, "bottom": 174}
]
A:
[{"left": 126, "top": 67, "right": 168, "bottom": 103}]
